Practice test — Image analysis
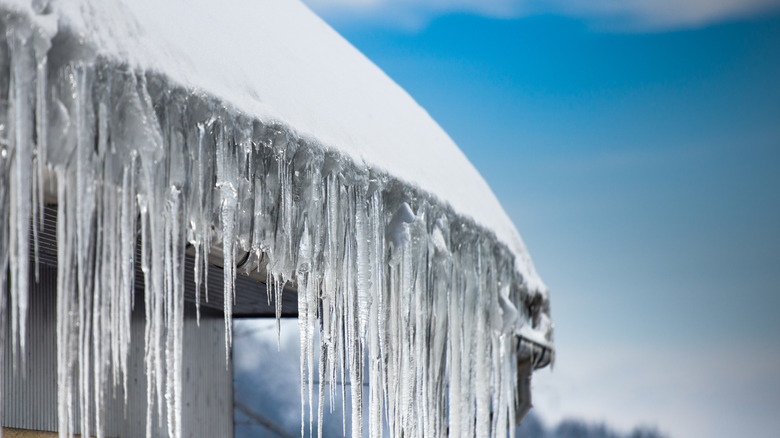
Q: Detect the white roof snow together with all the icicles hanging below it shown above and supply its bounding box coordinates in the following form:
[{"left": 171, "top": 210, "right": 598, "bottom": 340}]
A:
[{"left": 0, "top": 0, "right": 552, "bottom": 438}]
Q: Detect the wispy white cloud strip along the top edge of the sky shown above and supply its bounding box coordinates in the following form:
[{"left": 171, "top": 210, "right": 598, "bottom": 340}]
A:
[{"left": 304, "top": 0, "right": 780, "bottom": 32}]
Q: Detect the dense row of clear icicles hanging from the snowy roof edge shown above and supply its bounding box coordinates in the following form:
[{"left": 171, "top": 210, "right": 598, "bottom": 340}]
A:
[{"left": 0, "top": 15, "right": 548, "bottom": 438}]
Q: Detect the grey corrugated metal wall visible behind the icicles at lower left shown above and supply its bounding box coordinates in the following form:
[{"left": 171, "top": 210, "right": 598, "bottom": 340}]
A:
[{"left": 2, "top": 264, "right": 233, "bottom": 437}]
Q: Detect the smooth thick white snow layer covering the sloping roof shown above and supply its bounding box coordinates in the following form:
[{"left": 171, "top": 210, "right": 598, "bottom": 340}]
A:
[{"left": 6, "top": 0, "right": 545, "bottom": 291}]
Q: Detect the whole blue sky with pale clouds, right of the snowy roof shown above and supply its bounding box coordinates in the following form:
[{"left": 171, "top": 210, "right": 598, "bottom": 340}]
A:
[{"left": 300, "top": 0, "right": 780, "bottom": 437}]
